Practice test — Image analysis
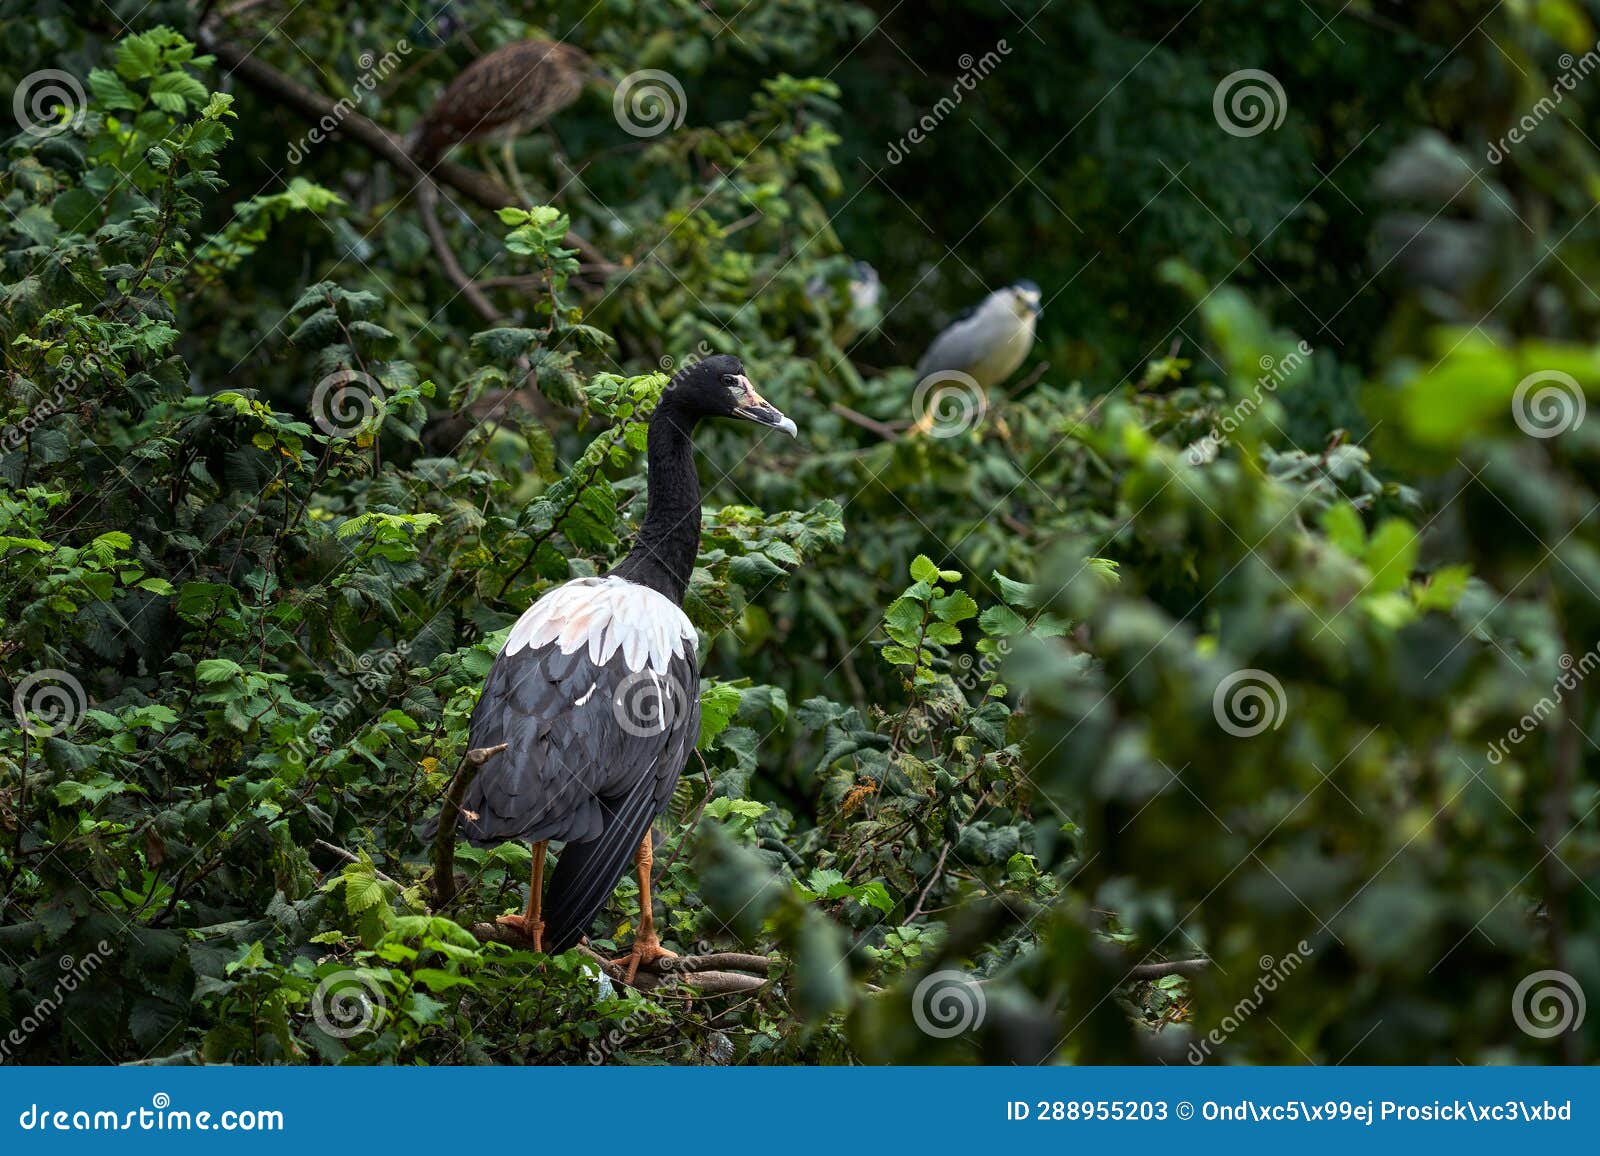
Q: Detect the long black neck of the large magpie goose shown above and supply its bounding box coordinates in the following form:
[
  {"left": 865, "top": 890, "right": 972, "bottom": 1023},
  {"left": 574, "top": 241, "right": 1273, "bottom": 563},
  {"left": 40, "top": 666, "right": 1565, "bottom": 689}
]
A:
[{"left": 611, "top": 394, "right": 701, "bottom": 604}]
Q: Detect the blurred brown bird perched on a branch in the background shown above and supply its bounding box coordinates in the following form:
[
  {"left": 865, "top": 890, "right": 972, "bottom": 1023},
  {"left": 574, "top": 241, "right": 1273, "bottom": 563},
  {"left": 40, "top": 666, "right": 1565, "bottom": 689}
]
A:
[{"left": 408, "top": 40, "right": 600, "bottom": 167}]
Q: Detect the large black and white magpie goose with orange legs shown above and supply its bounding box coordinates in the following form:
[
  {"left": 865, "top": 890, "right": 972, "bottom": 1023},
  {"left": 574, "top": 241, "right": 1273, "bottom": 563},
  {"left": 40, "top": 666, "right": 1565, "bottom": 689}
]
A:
[{"left": 441, "top": 355, "right": 795, "bottom": 981}]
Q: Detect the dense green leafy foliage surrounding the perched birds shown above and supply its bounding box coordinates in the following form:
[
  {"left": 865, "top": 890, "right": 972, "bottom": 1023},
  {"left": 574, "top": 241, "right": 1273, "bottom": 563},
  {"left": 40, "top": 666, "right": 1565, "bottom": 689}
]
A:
[{"left": 0, "top": 0, "right": 1600, "bottom": 1063}]
